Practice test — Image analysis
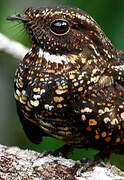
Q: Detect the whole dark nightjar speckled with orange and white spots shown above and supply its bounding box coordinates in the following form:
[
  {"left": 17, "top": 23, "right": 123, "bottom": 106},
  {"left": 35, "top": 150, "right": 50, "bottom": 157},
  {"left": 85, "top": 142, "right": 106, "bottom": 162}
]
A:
[{"left": 8, "top": 7, "right": 124, "bottom": 159}]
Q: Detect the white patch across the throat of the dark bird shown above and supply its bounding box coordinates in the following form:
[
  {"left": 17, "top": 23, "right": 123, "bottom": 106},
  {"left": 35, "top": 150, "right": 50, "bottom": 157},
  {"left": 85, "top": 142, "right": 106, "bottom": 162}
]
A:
[{"left": 39, "top": 48, "right": 69, "bottom": 64}]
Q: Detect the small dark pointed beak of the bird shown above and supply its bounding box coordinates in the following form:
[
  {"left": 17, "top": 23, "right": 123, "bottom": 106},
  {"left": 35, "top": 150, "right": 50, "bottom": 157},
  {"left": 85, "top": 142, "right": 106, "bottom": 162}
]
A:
[{"left": 7, "top": 14, "right": 28, "bottom": 22}]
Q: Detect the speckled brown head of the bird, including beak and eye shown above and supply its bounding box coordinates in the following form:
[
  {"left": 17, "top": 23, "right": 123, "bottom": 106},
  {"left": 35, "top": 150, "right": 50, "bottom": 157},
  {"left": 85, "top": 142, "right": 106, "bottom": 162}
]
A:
[{"left": 8, "top": 7, "right": 116, "bottom": 57}]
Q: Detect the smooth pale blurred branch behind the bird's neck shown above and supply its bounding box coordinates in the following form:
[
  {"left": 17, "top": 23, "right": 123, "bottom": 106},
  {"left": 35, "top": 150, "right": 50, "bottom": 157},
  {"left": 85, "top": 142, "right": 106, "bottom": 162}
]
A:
[{"left": 0, "top": 33, "right": 28, "bottom": 60}]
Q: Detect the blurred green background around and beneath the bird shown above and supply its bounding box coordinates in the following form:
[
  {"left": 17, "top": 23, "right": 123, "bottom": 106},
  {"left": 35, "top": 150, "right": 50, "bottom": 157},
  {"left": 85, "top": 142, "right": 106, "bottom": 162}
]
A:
[{"left": 0, "top": 0, "right": 124, "bottom": 170}]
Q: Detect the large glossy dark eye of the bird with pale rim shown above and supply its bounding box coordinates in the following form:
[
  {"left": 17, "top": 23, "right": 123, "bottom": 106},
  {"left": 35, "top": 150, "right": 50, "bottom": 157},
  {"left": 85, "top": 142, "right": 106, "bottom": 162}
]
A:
[{"left": 50, "top": 20, "right": 70, "bottom": 36}]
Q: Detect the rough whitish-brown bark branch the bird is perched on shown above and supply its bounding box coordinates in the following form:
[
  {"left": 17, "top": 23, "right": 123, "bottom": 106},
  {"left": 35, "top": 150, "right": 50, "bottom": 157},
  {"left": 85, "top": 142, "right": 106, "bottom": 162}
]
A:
[{"left": 0, "top": 145, "right": 124, "bottom": 180}]
